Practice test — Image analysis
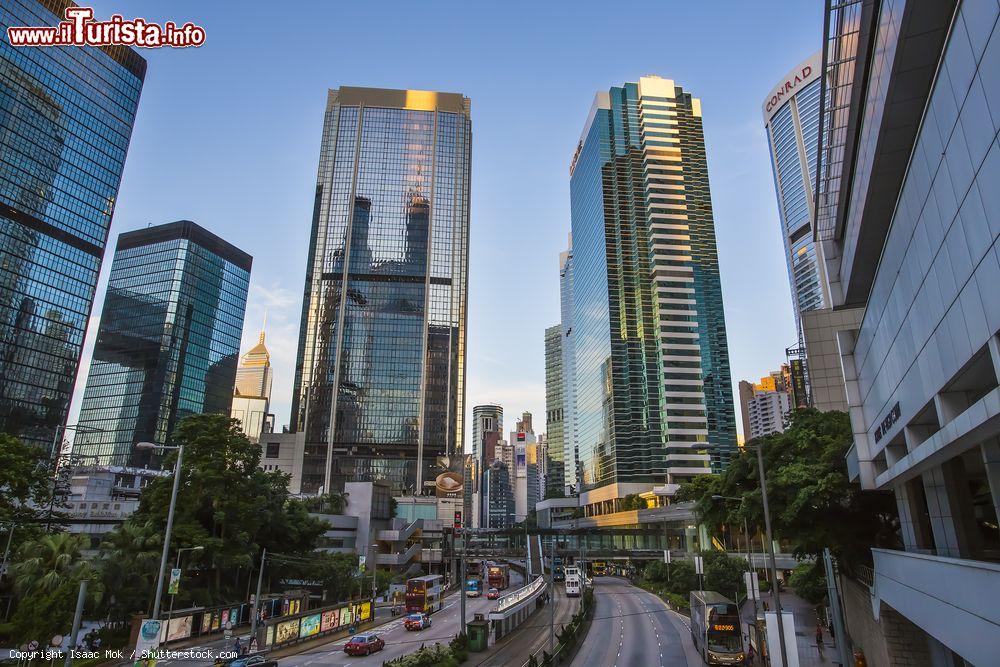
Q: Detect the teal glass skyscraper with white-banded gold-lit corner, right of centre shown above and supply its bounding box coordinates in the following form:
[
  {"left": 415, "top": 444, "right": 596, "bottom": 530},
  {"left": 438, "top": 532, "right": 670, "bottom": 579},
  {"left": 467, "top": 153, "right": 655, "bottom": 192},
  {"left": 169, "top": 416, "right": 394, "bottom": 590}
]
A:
[{"left": 570, "top": 77, "right": 736, "bottom": 507}]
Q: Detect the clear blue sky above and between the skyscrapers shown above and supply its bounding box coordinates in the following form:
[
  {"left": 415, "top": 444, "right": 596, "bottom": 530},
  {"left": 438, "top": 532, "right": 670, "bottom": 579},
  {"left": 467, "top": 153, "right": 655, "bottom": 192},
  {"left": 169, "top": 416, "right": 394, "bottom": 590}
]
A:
[{"left": 71, "top": 0, "right": 822, "bottom": 446}]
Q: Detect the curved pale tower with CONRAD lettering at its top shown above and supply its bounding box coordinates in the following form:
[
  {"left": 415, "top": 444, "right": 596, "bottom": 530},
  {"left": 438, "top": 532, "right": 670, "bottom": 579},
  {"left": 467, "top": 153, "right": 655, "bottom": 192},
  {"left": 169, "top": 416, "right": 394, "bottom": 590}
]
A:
[{"left": 762, "top": 52, "right": 830, "bottom": 340}]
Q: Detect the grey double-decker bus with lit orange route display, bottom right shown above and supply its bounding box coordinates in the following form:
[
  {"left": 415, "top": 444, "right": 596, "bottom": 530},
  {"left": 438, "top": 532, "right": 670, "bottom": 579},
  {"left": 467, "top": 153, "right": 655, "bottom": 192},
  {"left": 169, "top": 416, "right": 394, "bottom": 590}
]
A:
[{"left": 690, "top": 591, "right": 745, "bottom": 665}]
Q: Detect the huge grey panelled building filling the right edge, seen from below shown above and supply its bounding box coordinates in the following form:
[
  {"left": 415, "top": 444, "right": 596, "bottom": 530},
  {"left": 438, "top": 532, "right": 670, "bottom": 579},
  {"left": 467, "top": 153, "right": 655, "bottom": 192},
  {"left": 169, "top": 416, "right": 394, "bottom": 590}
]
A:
[{"left": 802, "top": 0, "right": 1000, "bottom": 667}]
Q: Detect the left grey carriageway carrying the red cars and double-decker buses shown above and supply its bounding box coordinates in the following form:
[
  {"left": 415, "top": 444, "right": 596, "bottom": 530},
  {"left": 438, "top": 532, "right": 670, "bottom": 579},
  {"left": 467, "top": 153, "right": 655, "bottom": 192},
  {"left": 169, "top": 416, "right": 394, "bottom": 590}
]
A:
[{"left": 278, "top": 571, "right": 523, "bottom": 667}]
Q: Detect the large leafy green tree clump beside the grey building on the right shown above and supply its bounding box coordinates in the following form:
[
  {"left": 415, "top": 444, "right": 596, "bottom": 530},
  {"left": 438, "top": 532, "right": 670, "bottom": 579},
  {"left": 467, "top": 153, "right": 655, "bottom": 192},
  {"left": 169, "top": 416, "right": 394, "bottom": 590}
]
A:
[{"left": 679, "top": 409, "right": 899, "bottom": 573}]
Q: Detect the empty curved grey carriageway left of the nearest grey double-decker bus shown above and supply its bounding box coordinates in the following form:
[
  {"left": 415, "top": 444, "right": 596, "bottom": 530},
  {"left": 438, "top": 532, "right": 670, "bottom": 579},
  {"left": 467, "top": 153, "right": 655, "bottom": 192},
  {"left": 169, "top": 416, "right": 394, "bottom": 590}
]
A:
[{"left": 573, "top": 577, "right": 702, "bottom": 667}]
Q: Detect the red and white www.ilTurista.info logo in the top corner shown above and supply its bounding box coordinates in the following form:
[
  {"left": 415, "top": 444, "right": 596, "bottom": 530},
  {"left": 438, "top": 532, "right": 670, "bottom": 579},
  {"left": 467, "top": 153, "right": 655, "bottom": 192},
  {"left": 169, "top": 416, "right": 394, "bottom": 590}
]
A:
[{"left": 7, "top": 7, "right": 205, "bottom": 49}]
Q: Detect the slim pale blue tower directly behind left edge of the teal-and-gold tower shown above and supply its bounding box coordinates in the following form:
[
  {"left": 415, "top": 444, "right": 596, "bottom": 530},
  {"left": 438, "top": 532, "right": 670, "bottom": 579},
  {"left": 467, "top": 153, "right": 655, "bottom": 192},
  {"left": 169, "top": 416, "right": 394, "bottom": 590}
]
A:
[{"left": 559, "top": 233, "right": 580, "bottom": 494}]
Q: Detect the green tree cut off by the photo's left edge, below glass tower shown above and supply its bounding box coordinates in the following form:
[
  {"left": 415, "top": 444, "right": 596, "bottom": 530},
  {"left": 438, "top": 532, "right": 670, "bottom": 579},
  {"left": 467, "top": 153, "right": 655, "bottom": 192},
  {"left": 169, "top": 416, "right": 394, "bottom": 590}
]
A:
[{"left": 0, "top": 433, "right": 52, "bottom": 539}]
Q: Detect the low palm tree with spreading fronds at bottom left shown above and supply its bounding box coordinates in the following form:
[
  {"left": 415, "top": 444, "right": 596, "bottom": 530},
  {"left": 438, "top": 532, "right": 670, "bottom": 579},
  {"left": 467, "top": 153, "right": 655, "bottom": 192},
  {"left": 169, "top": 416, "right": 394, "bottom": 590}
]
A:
[{"left": 10, "top": 533, "right": 91, "bottom": 597}]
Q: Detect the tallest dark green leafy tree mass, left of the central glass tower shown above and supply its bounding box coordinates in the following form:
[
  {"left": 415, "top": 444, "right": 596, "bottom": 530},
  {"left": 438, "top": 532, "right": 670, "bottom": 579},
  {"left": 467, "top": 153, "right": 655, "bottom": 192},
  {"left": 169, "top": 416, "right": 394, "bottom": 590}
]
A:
[{"left": 119, "top": 414, "right": 327, "bottom": 604}]
